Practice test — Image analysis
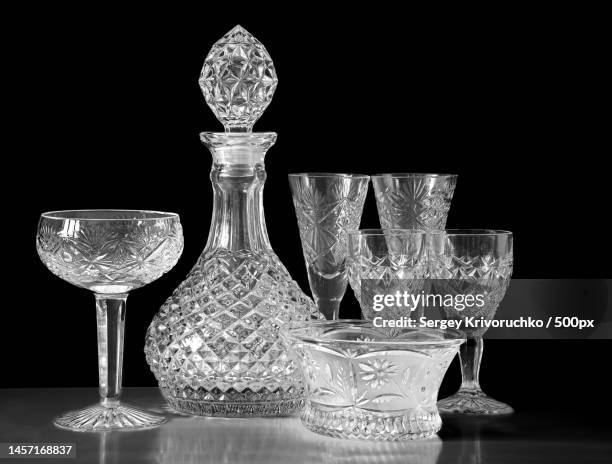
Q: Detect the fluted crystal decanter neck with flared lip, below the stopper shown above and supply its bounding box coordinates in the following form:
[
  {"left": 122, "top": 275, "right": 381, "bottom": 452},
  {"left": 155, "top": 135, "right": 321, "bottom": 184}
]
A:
[{"left": 202, "top": 132, "right": 276, "bottom": 252}]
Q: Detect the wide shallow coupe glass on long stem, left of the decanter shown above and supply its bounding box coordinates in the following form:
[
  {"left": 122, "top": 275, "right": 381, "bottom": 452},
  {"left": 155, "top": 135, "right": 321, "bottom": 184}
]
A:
[{"left": 36, "top": 210, "right": 183, "bottom": 431}]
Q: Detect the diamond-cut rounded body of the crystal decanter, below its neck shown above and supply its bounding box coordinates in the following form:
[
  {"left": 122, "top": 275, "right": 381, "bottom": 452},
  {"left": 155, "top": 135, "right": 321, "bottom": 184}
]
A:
[{"left": 145, "top": 249, "right": 319, "bottom": 415}]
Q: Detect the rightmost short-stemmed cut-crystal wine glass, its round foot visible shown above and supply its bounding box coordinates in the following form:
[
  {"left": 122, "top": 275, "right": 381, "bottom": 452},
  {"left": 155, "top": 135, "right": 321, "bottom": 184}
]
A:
[{"left": 431, "top": 229, "right": 513, "bottom": 414}]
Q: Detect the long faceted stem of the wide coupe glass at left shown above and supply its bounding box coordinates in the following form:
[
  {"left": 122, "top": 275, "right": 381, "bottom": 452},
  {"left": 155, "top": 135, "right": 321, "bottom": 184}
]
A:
[{"left": 95, "top": 293, "right": 127, "bottom": 407}]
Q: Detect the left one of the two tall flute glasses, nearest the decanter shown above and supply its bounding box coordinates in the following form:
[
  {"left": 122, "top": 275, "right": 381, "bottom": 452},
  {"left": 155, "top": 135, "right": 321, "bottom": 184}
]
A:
[{"left": 289, "top": 172, "right": 370, "bottom": 319}]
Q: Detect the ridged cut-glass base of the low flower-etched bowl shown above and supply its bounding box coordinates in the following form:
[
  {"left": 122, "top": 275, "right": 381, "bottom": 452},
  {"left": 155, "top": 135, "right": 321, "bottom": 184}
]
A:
[{"left": 301, "top": 400, "right": 442, "bottom": 441}]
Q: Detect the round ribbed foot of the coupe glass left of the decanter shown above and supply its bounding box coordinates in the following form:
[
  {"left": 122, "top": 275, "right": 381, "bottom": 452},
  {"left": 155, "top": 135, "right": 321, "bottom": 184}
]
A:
[{"left": 53, "top": 403, "right": 166, "bottom": 432}]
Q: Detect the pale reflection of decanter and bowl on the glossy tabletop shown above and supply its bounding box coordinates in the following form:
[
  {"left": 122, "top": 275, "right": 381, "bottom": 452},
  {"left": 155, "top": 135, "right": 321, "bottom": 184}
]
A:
[{"left": 156, "top": 417, "right": 442, "bottom": 464}]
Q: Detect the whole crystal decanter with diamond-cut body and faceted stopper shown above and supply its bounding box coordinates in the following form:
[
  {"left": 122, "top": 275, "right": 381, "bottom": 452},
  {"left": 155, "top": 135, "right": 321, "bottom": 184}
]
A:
[{"left": 145, "top": 26, "right": 322, "bottom": 416}]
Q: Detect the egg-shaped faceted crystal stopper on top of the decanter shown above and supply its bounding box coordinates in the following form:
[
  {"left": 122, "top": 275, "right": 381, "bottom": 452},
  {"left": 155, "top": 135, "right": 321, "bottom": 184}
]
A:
[{"left": 199, "top": 26, "right": 278, "bottom": 132}]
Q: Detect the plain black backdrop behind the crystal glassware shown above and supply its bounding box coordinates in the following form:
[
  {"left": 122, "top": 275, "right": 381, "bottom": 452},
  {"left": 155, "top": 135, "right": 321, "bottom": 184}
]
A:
[{"left": 0, "top": 4, "right": 610, "bottom": 416}]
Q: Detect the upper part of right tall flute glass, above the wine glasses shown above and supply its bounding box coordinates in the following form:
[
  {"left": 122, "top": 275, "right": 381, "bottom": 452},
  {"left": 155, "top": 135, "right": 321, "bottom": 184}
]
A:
[{"left": 372, "top": 173, "right": 457, "bottom": 230}]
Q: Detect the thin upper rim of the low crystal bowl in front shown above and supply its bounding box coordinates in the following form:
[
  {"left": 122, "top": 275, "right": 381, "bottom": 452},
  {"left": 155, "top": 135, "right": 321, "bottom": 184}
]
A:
[{"left": 281, "top": 319, "right": 466, "bottom": 348}]
